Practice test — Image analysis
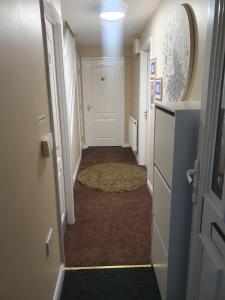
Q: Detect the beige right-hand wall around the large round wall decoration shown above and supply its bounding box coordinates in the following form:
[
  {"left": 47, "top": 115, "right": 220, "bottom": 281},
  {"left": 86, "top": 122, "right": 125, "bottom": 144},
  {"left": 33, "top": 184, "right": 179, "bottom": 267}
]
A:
[{"left": 133, "top": 0, "right": 208, "bottom": 184}]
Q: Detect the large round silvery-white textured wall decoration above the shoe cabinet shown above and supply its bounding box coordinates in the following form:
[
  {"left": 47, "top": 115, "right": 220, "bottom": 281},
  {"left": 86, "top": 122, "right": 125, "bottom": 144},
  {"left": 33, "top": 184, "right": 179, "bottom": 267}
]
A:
[{"left": 163, "top": 4, "right": 194, "bottom": 102}]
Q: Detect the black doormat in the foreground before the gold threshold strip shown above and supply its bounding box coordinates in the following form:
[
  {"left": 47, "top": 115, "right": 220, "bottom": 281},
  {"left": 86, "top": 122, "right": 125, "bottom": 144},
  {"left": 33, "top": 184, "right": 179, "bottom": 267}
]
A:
[{"left": 60, "top": 267, "right": 161, "bottom": 300}]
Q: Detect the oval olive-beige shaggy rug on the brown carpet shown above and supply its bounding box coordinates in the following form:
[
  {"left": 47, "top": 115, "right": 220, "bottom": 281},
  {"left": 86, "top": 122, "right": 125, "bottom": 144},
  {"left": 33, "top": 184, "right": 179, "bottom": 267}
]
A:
[{"left": 78, "top": 163, "right": 147, "bottom": 193}]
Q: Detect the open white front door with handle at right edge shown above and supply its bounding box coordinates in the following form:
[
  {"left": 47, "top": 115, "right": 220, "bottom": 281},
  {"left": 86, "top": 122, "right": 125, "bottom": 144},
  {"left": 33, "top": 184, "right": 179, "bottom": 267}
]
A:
[{"left": 187, "top": 0, "right": 225, "bottom": 300}]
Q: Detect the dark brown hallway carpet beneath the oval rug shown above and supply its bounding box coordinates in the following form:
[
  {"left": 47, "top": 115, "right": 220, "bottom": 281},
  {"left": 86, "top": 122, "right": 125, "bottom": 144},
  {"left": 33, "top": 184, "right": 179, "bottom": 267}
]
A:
[{"left": 64, "top": 147, "right": 152, "bottom": 267}]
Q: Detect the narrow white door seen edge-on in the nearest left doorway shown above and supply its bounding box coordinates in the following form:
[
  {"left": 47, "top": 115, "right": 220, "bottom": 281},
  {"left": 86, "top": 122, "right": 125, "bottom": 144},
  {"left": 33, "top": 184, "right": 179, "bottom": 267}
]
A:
[{"left": 46, "top": 20, "right": 66, "bottom": 223}]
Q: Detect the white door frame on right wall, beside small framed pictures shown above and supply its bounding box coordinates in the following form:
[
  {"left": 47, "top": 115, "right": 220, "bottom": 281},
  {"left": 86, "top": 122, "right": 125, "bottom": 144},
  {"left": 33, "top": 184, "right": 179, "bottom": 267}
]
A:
[{"left": 138, "top": 39, "right": 151, "bottom": 166}]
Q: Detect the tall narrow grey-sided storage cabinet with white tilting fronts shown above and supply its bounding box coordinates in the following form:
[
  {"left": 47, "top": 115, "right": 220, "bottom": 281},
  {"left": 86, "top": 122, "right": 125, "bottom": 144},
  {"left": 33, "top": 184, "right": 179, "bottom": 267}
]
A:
[{"left": 152, "top": 102, "right": 200, "bottom": 300}]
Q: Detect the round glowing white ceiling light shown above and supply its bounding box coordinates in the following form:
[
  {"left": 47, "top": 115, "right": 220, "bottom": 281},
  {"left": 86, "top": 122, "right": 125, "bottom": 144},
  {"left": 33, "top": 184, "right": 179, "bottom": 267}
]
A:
[{"left": 100, "top": 0, "right": 127, "bottom": 21}]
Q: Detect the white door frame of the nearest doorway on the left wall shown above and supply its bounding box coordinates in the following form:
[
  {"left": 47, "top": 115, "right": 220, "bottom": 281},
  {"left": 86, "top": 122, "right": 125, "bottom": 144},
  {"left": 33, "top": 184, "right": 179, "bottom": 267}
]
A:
[{"left": 41, "top": 0, "right": 75, "bottom": 230}]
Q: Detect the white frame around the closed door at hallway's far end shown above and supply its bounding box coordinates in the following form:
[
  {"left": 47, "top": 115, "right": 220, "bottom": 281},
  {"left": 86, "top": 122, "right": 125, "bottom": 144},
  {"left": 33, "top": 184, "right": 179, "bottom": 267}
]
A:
[{"left": 81, "top": 57, "right": 125, "bottom": 148}]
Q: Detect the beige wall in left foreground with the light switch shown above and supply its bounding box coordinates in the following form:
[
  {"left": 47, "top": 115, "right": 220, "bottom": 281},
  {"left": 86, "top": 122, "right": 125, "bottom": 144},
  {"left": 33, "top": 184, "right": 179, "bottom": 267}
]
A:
[{"left": 0, "top": 0, "right": 61, "bottom": 300}]
